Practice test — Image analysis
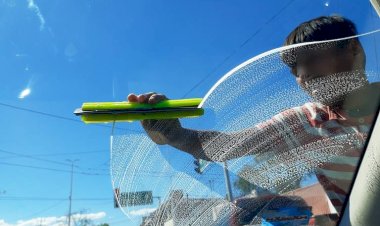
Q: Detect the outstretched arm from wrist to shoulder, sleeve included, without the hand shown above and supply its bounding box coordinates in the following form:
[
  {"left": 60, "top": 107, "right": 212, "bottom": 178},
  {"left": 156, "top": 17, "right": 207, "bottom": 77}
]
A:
[{"left": 166, "top": 110, "right": 304, "bottom": 162}]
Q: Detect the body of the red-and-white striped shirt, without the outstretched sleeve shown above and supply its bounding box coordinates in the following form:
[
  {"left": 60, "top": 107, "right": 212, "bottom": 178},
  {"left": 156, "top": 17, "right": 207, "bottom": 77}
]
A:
[{"left": 302, "top": 103, "right": 373, "bottom": 213}]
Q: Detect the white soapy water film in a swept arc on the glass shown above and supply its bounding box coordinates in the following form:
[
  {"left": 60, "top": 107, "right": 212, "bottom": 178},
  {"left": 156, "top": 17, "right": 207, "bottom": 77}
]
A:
[{"left": 111, "top": 32, "right": 379, "bottom": 225}]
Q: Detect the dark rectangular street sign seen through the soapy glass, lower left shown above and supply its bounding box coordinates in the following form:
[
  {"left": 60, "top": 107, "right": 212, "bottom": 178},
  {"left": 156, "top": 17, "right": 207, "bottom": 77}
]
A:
[{"left": 114, "top": 188, "right": 153, "bottom": 208}]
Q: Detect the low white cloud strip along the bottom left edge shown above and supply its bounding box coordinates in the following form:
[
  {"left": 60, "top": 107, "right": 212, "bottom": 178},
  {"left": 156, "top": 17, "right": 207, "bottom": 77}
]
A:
[{"left": 0, "top": 212, "right": 106, "bottom": 226}]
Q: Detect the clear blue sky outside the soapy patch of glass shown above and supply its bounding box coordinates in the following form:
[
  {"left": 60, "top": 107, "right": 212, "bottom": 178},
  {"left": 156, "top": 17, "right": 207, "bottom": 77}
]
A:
[{"left": 0, "top": 0, "right": 380, "bottom": 225}]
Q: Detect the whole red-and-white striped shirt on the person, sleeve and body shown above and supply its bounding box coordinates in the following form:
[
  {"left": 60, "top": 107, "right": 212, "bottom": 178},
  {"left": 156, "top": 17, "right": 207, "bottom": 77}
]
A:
[{"left": 197, "top": 103, "right": 373, "bottom": 213}]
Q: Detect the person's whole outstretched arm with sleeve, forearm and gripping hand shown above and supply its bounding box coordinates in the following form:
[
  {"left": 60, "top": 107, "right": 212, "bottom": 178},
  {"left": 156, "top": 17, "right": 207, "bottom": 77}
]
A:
[{"left": 128, "top": 93, "right": 303, "bottom": 161}]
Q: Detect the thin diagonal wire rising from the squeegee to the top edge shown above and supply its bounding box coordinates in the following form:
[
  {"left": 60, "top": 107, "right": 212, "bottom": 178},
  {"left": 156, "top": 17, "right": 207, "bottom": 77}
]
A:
[{"left": 182, "top": 0, "right": 296, "bottom": 98}]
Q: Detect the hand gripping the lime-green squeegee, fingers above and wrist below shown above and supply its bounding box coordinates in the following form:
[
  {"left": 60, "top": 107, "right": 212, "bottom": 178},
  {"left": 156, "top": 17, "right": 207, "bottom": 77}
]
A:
[{"left": 128, "top": 92, "right": 182, "bottom": 144}]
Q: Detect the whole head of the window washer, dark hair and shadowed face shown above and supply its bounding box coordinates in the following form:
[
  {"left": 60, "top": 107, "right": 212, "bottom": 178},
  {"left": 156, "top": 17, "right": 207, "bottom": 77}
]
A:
[{"left": 281, "top": 16, "right": 367, "bottom": 105}]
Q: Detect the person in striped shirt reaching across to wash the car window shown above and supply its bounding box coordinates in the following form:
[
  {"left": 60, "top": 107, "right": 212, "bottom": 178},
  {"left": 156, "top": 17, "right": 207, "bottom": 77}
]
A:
[{"left": 128, "top": 15, "right": 380, "bottom": 217}]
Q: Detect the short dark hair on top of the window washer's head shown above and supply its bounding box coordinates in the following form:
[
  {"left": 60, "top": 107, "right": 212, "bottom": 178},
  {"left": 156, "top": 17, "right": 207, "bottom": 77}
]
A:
[{"left": 281, "top": 15, "right": 358, "bottom": 67}]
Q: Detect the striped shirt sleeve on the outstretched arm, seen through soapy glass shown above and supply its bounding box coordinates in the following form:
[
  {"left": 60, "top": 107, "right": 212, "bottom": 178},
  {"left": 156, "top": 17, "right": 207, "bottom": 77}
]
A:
[{"left": 198, "top": 107, "right": 312, "bottom": 162}]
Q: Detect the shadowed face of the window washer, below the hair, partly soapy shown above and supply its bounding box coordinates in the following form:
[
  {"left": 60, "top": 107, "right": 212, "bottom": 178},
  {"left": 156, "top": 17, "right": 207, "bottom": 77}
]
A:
[{"left": 291, "top": 42, "right": 366, "bottom": 106}]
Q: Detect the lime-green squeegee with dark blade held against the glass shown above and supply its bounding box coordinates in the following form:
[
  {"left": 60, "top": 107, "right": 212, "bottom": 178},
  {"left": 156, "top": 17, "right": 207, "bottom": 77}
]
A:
[{"left": 74, "top": 98, "right": 204, "bottom": 123}]
